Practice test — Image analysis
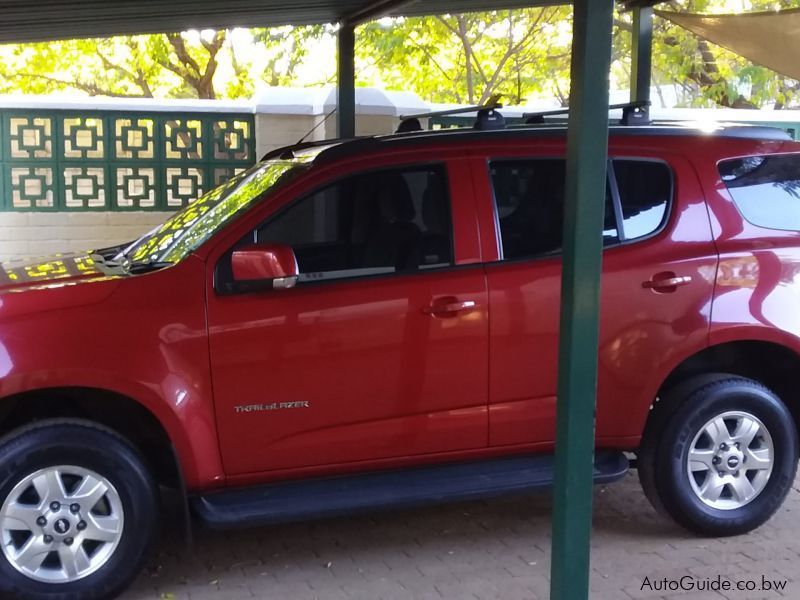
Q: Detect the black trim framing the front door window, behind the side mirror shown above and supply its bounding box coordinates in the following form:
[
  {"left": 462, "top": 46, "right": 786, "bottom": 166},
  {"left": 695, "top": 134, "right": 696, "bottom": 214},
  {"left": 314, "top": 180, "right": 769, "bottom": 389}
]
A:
[{"left": 214, "top": 159, "right": 460, "bottom": 296}]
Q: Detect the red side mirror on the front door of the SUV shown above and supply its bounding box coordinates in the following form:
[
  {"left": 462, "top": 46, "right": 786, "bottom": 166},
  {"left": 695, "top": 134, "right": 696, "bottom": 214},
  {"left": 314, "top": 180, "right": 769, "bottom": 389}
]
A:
[{"left": 231, "top": 244, "right": 300, "bottom": 289}]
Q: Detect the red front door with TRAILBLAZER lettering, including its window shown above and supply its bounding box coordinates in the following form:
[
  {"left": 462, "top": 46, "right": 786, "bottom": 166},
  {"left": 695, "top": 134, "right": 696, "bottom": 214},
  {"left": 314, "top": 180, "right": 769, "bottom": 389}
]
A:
[{"left": 208, "top": 160, "right": 488, "bottom": 475}]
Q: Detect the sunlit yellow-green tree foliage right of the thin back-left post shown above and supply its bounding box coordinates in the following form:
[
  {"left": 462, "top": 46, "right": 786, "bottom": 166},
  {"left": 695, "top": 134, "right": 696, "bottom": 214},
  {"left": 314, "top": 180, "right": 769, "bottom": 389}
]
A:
[{"left": 359, "top": 0, "right": 800, "bottom": 108}]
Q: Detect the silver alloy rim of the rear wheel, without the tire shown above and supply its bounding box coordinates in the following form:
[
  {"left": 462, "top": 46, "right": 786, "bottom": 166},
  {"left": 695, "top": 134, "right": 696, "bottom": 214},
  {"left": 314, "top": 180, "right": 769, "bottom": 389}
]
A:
[{"left": 686, "top": 411, "right": 775, "bottom": 510}]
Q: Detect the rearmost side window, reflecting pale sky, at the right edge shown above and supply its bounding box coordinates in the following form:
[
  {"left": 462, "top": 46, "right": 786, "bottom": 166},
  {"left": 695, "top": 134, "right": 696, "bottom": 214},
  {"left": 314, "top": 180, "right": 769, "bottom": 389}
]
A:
[{"left": 719, "top": 154, "right": 800, "bottom": 231}]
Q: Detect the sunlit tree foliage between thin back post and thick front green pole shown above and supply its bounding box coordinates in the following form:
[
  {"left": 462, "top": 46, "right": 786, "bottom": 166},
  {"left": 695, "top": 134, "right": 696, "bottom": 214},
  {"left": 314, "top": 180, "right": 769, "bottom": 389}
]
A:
[{"left": 357, "top": 7, "right": 571, "bottom": 104}]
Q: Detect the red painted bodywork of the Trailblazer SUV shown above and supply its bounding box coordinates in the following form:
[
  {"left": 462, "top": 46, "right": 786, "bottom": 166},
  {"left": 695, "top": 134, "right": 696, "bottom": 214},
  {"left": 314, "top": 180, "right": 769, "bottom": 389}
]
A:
[{"left": 0, "top": 134, "right": 800, "bottom": 491}]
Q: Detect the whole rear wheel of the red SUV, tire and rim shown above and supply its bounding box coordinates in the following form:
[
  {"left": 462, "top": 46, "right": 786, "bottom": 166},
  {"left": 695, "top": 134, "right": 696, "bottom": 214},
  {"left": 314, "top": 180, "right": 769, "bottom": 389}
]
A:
[{"left": 644, "top": 376, "right": 798, "bottom": 536}]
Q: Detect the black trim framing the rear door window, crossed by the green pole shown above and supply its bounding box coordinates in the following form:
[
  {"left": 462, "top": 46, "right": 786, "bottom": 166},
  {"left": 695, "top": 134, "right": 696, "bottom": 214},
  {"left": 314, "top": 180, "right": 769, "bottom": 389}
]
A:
[{"left": 484, "top": 154, "right": 676, "bottom": 264}]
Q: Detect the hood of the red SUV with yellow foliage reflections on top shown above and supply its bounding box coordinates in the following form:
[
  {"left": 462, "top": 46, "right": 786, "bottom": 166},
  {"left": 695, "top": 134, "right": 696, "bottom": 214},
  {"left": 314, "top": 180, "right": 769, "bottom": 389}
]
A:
[{"left": 0, "top": 252, "right": 125, "bottom": 294}]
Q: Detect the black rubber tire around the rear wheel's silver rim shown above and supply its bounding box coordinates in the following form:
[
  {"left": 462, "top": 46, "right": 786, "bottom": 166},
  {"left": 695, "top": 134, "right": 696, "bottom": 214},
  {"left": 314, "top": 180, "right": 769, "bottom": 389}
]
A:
[{"left": 639, "top": 374, "right": 798, "bottom": 536}]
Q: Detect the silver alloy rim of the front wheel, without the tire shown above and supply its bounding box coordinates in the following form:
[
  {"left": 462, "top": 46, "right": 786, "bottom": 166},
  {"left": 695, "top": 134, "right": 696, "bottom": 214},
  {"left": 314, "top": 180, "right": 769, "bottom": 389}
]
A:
[{"left": 0, "top": 466, "right": 124, "bottom": 584}]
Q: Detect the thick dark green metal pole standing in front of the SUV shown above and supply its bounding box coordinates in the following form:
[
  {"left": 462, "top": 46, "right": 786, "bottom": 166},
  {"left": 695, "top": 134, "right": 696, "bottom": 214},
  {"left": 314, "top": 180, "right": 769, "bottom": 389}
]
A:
[{"left": 550, "top": 0, "right": 614, "bottom": 600}]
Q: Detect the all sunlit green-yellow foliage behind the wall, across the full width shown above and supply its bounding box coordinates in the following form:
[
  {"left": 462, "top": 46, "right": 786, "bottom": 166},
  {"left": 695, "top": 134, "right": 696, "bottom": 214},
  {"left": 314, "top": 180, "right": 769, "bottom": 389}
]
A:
[{"left": 0, "top": 0, "right": 800, "bottom": 108}]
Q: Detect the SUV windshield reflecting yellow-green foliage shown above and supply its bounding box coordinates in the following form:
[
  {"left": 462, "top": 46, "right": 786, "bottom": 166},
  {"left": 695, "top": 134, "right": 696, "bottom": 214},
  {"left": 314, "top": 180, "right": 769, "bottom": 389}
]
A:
[{"left": 116, "top": 157, "right": 311, "bottom": 265}]
